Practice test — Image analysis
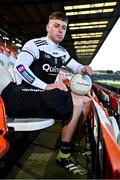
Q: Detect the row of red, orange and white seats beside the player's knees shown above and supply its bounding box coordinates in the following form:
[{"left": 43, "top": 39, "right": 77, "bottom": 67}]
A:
[{"left": 87, "top": 84, "right": 120, "bottom": 179}]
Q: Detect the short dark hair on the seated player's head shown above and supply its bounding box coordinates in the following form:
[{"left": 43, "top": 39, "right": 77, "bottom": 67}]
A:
[{"left": 49, "top": 11, "right": 68, "bottom": 23}]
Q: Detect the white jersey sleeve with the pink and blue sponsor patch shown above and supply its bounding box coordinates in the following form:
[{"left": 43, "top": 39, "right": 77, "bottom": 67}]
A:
[{"left": 14, "top": 42, "right": 47, "bottom": 89}]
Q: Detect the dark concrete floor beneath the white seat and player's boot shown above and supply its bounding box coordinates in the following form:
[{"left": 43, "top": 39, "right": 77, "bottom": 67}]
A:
[{"left": 0, "top": 122, "right": 88, "bottom": 179}]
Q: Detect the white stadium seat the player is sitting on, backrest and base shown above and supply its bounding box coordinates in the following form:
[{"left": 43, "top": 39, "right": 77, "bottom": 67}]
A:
[{"left": 0, "top": 62, "right": 55, "bottom": 131}]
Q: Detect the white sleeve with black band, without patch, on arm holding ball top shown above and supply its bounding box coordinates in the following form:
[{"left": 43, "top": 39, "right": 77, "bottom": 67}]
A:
[{"left": 65, "top": 51, "right": 83, "bottom": 73}]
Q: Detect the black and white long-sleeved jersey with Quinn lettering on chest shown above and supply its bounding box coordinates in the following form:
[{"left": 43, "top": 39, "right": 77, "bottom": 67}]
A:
[{"left": 15, "top": 37, "right": 83, "bottom": 89}]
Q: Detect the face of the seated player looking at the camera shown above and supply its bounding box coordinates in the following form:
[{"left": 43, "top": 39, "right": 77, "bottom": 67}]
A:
[{"left": 46, "top": 19, "right": 67, "bottom": 43}]
